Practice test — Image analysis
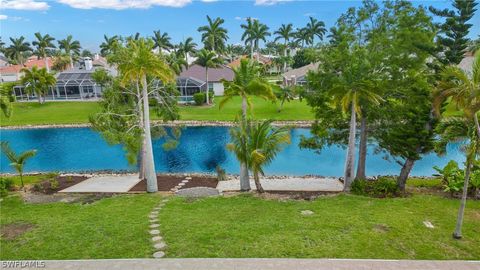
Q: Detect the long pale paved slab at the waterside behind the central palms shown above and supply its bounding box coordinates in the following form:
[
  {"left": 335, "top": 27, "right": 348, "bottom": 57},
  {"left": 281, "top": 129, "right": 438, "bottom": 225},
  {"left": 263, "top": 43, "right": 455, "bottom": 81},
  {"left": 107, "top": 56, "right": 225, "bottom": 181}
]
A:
[{"left": 217, "top": 177, "right": 343, "bottom": 192}]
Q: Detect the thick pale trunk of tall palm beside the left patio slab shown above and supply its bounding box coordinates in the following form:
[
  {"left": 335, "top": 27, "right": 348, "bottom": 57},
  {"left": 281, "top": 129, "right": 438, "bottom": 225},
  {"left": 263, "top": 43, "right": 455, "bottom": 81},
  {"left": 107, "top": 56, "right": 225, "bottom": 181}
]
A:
[{"left": 142, "top": 75, "right": 158, "bottom": 192}]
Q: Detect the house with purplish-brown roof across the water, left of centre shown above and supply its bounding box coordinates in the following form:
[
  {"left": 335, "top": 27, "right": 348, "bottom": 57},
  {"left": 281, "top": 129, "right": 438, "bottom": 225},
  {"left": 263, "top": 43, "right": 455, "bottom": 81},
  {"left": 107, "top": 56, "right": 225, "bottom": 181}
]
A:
[{"left": 176, "top": 64, "right": 234, "bottom": 101}]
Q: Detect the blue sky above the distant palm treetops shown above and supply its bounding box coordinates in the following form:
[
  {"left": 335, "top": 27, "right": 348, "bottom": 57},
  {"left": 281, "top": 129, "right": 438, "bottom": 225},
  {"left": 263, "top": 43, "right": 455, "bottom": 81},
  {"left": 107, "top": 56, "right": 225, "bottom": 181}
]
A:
[{"left": 0, "top": 0, "right": 480, "bottom": 52}]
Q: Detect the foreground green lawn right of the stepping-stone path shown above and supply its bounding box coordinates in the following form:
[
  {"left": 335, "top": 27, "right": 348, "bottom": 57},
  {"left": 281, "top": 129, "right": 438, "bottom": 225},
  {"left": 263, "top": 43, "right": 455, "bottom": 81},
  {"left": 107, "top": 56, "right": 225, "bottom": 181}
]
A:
[{"left": 160, "top": 195, "right": 480, "bottom": 260}]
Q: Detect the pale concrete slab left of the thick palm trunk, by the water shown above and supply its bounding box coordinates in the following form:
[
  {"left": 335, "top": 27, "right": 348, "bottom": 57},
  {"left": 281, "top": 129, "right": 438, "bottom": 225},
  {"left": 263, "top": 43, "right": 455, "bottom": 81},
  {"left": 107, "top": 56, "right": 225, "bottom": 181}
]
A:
[{"left": 59, "top": 174, "right": 140, "bottom": 193}]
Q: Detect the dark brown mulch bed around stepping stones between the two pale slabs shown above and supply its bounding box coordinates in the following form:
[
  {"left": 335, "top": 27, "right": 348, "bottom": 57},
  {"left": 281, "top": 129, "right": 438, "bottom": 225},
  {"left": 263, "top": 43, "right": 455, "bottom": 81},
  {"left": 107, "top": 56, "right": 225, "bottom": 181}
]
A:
[{"left": 130, "top": 175, "right": 218, "bottom": 192}]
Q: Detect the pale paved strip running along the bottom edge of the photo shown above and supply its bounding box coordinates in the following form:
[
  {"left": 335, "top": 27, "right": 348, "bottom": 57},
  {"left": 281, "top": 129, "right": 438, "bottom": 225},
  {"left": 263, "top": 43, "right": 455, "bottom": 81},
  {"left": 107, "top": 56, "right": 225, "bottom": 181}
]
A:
[{"left": 5, "top": 259, "right": 480, "bottom": 270}]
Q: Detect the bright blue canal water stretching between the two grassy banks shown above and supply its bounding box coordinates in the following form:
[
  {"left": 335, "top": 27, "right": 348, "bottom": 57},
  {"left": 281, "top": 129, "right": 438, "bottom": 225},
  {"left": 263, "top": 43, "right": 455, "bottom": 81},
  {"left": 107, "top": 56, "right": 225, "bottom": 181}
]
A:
[{"left": 0, "top": 127, "right": 463, "bottom": 176}]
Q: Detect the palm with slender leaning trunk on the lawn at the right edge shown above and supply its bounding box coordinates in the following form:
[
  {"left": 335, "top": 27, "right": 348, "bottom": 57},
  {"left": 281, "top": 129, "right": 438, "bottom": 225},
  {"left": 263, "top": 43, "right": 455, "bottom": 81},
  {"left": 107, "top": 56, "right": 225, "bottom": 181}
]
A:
[{"left": 433, "top": 53, "right": 480, "bottom": 239}]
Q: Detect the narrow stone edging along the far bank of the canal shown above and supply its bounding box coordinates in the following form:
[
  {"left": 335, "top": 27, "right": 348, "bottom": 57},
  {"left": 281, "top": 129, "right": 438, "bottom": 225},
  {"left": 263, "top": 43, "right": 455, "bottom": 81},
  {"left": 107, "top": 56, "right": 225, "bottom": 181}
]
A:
[{"left": 0, "top": 120, "right": 314, "bottom": 130}]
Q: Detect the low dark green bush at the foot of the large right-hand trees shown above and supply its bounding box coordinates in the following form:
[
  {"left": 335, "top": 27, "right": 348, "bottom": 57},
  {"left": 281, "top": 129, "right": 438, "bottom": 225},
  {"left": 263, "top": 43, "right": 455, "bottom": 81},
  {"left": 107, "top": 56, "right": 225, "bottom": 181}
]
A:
[{"left": 351, "top": 177, "right": 399, "bottom": 198}]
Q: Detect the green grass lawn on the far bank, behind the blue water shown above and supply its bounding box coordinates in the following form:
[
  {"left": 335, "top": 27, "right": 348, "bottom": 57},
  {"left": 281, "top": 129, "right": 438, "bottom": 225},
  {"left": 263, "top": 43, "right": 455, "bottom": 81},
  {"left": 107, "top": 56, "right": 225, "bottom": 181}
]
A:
[{"left": 0, "top": 97, "right": 313, "bottom": 126}]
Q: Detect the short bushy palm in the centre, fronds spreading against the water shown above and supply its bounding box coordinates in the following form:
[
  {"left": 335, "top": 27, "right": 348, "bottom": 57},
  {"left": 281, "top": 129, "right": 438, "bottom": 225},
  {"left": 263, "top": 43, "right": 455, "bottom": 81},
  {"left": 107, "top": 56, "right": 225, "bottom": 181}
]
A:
[{"left": 227, "top": 120, "right": 290, "bottom": 193}]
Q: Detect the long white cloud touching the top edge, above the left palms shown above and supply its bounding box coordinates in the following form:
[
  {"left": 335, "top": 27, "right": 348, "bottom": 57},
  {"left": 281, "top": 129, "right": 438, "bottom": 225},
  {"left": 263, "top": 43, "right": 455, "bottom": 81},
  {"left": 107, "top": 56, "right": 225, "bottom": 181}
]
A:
[{"left": 58, "top": 0, "right": 192, "bottom": 10}]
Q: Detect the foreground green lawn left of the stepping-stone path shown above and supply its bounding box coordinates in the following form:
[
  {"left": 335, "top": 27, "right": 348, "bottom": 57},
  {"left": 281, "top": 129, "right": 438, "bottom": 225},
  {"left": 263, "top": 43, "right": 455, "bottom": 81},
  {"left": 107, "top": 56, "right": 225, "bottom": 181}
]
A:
[{"left": 0, "top": 194, "right": 160, "bottom": 260}]
